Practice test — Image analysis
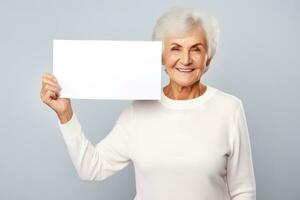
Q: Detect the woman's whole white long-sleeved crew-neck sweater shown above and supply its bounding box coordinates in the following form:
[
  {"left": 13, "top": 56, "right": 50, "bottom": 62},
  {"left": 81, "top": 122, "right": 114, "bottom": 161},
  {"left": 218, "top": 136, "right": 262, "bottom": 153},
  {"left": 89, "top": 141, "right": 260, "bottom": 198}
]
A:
[{"left": 58, "top": 85, "right": 256, "bottom": 200}]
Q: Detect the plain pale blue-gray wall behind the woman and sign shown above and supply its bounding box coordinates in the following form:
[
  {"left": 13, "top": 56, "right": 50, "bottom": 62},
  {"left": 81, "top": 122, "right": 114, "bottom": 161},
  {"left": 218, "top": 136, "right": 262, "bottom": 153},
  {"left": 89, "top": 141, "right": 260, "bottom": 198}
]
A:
[{"left": 0, "top": 0, "right": 300, "bottom": 200}]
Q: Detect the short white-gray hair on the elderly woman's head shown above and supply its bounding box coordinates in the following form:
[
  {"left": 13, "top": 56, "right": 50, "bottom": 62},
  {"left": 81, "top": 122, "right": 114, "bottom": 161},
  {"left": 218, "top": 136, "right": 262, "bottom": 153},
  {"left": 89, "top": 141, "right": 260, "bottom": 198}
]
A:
[{"left": 152, "top": 8, "right": 220, "bottom": 59}]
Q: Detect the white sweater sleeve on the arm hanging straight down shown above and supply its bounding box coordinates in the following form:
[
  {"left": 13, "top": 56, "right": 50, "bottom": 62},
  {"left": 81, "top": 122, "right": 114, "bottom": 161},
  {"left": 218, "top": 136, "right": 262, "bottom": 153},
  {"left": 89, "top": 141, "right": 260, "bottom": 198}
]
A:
[{"left": 227, "top": 100, "right": 256, "bottom": 200}]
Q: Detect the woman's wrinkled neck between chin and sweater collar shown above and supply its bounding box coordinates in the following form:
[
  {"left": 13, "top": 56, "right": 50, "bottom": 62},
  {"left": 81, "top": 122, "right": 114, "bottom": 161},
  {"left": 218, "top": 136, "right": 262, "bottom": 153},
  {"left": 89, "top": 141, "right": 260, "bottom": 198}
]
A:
[{"left": 163, "top": 81, "right": 207, "bottom": 100}]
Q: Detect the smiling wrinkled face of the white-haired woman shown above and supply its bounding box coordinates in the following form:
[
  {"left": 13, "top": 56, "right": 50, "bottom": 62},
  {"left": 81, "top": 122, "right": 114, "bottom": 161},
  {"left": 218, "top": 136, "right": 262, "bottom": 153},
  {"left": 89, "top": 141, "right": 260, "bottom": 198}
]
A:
[{"left": 162, "top": 28, "right": 210, "bottom": 86}]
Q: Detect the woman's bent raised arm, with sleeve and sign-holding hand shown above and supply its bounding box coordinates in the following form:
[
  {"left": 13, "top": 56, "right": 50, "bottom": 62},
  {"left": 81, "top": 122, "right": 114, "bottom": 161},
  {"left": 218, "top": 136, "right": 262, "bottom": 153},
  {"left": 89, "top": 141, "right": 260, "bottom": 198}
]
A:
[{"left": 40, "top": 73, "right": 132, "bottom": 180}]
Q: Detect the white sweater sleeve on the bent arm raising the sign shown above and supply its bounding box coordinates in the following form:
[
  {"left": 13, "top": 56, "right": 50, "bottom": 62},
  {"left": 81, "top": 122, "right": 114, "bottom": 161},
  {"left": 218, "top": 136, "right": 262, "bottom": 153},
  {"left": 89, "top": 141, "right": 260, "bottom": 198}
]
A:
[{"left": 58, "top": 105, "right": 132, "bottom": 181}]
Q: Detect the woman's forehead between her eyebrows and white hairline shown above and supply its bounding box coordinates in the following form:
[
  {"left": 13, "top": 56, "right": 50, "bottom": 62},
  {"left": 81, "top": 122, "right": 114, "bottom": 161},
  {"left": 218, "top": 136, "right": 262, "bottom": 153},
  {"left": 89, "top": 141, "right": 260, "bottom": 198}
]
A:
[{"left": 164, "top": 28, "right": 206, "bottom": 45}]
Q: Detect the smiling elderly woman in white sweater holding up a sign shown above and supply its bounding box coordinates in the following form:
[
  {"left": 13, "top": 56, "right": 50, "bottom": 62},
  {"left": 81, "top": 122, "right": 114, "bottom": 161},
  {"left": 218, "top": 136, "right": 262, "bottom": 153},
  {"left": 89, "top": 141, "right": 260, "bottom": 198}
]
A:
[{"left": 41, "top": 9, "right": 256, "bottom": 200}]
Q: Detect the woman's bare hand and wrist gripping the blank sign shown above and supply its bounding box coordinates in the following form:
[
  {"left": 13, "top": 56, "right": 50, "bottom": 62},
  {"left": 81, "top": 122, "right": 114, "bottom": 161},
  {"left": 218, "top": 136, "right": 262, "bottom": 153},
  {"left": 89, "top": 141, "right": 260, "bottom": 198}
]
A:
[{"left": 40, "top": 73, "right": 73, "bottom": 124}]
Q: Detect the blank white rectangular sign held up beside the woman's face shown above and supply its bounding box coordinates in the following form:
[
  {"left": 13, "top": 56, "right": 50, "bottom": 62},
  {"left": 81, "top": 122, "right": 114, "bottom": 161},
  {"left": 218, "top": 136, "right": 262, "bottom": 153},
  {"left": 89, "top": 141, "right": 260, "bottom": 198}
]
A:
[{"left": 53, "top": 40, "right": 162, "bottom": 100}]
